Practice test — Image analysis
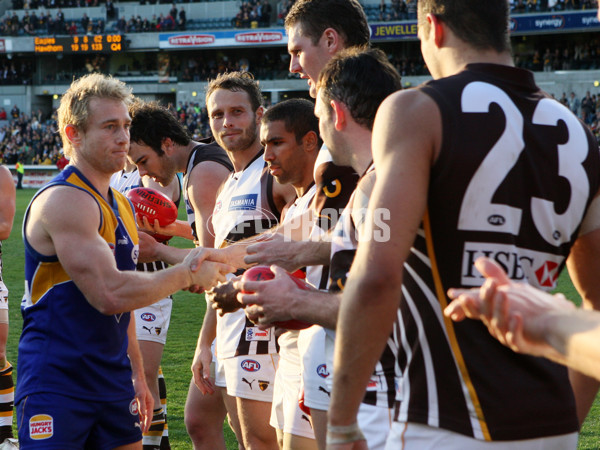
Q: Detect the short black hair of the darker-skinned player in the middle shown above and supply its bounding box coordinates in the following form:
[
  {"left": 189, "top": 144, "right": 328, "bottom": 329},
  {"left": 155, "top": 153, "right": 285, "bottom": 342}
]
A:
[{"left": 261, "top": 98, "right": 321, "bottom": 147}]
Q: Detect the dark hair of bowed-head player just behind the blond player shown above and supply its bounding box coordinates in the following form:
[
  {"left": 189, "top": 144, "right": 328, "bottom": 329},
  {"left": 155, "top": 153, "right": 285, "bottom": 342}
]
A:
[{"left": 129, "top": 99, "right": 191, "bottom": 156}]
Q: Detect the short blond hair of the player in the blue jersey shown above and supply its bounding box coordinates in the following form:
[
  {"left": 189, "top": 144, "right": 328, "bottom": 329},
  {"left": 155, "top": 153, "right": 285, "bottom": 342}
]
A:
[{"left": 58, "top": 73, "right": 133, "bottom": 158}]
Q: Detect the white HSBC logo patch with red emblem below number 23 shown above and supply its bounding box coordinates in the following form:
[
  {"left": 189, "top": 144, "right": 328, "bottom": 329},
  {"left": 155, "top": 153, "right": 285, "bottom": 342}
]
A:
[{"left": 461, "top": 242, "right": 565, "bottom": 290}]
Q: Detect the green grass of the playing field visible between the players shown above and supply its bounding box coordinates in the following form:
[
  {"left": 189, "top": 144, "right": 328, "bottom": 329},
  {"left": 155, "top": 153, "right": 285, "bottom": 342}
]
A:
[{"left": 2, "top": 189, "right": 600, "bottom": 450}]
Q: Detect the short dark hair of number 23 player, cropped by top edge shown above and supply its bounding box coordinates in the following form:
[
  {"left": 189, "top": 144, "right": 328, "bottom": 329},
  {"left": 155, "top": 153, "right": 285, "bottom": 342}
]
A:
[{"left": 418, "top": 0, "right": 510, "bottom": 53}]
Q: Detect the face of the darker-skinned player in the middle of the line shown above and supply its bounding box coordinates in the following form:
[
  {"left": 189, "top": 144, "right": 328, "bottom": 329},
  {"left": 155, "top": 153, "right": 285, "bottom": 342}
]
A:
[{"left": 260, "top": 120, "right": 305, "bottom": 187}]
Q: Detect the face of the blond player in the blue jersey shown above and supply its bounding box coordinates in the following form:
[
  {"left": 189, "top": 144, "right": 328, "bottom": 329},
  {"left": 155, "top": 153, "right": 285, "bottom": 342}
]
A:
[{"left": 75, "top": 98, "right": 131, "bottom": 173}]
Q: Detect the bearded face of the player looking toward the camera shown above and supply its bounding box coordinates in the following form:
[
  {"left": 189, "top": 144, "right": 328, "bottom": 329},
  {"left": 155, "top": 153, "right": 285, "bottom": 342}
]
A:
[{"left": 206, "top": 89, "right": 262, "bottom": 152}]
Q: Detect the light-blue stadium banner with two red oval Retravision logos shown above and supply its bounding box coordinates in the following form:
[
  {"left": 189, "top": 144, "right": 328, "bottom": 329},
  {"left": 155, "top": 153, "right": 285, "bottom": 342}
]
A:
[{"left": 158, "top": 28, "right": 287, "bottom": 48}]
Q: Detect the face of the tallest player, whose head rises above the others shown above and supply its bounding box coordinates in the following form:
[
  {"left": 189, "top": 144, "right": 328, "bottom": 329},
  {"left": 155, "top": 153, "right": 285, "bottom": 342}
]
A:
[{"left": 287, "top": 23, "right": 332, "bottom": 98}]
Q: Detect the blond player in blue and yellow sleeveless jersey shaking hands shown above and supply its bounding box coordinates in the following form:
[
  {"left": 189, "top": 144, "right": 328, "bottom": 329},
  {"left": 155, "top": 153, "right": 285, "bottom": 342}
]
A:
[{"left": 16, "top": 74, "right": 229, "bottom": 450}]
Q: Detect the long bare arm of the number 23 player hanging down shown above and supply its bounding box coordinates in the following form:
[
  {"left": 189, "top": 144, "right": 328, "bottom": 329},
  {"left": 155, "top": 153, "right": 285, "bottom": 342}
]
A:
[{"left": 329, "top": 91, "right": 441, "bottom": 439}]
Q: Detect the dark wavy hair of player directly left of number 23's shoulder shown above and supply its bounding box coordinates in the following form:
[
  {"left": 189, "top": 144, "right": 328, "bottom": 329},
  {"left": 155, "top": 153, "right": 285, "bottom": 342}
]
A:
[{"left": 317, "top": 48, "right": 402, "bottom": 130}]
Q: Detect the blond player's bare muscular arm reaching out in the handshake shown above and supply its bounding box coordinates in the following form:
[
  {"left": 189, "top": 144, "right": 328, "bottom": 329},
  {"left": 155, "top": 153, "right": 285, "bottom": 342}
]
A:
[{"left": 26, "top": 186, "right": 229, "bottom": 314}]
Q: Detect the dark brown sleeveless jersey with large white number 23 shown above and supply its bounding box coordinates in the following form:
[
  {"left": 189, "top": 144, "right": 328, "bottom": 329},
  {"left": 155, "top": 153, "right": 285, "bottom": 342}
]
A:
[{"left": 396, "top": 64, "right": 600, "bottom": 440}]
